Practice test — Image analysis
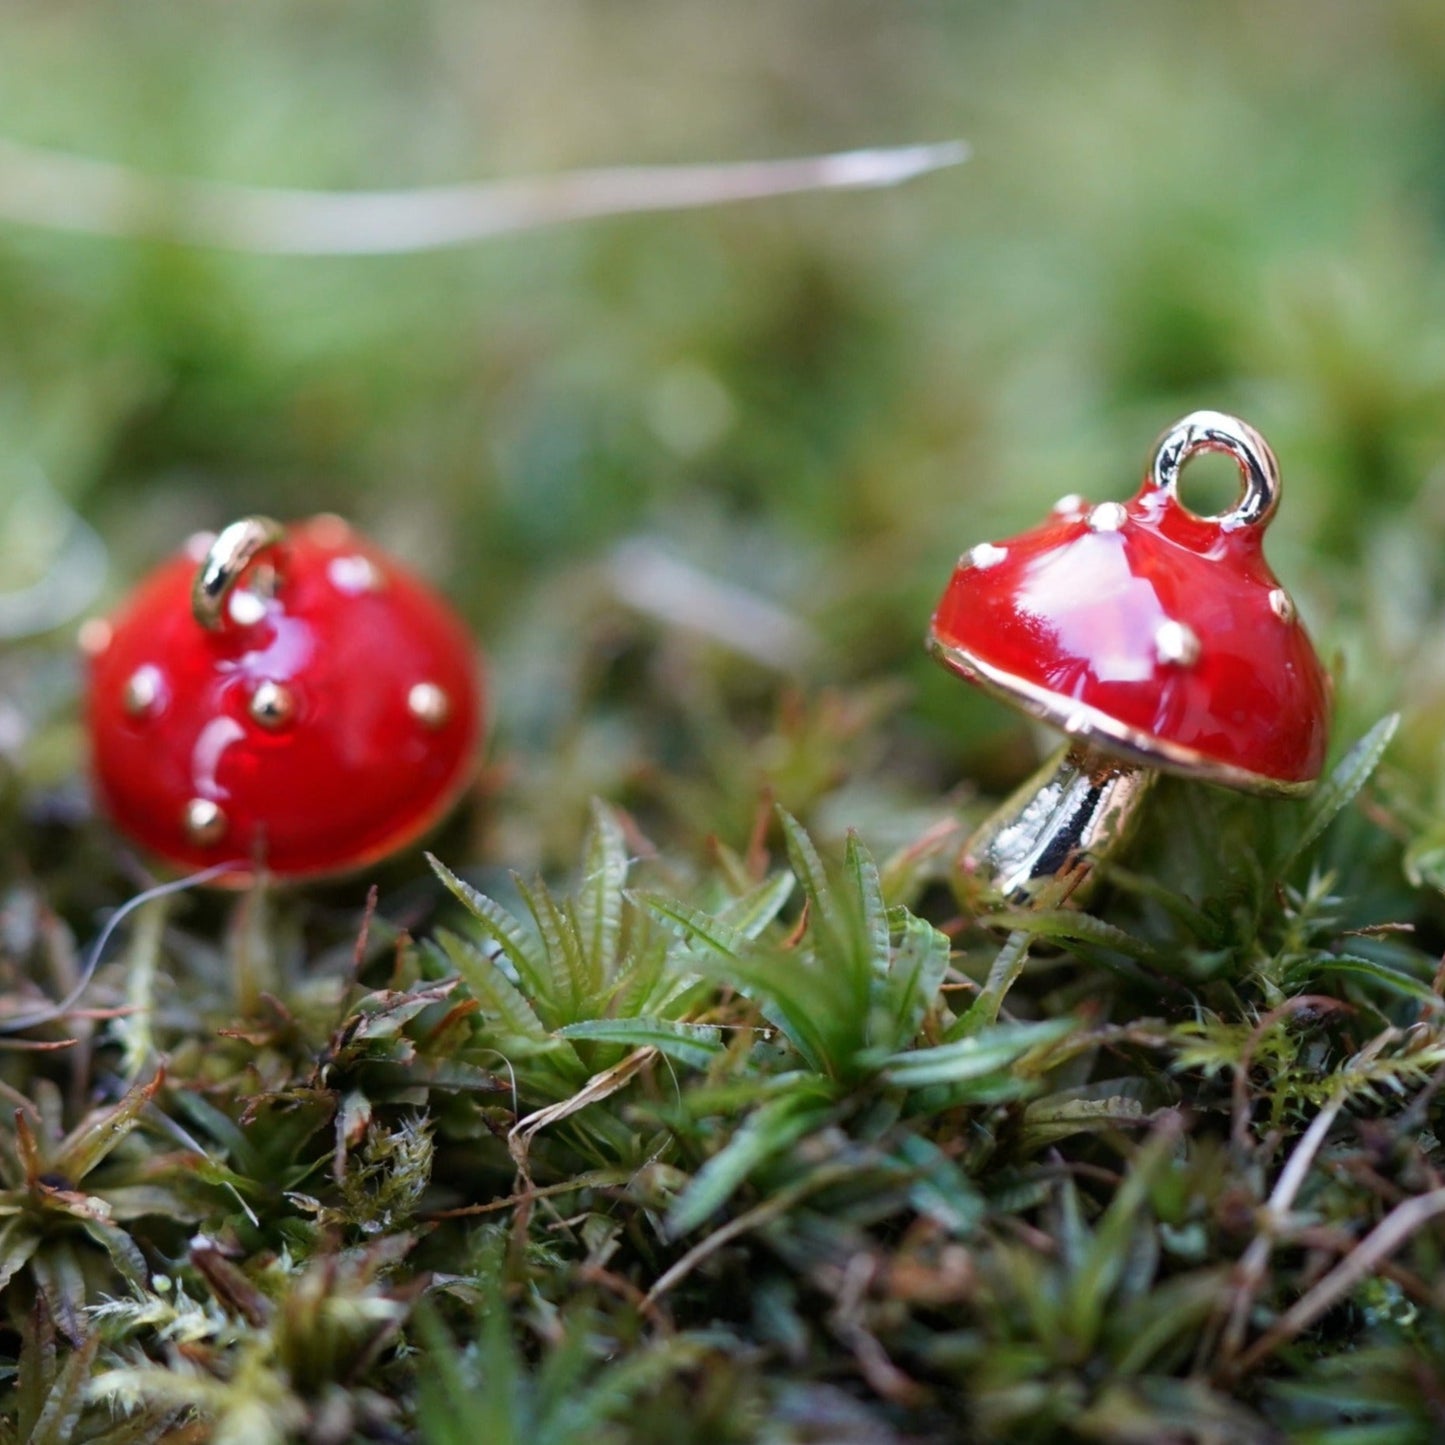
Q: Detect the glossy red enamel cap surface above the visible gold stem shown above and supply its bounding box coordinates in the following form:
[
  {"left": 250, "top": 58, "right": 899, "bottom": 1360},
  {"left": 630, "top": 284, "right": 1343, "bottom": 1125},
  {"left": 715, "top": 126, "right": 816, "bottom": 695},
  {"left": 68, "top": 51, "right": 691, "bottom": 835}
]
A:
[{"left": 931, "top": 486, "right": 1329, "bottom": 783}]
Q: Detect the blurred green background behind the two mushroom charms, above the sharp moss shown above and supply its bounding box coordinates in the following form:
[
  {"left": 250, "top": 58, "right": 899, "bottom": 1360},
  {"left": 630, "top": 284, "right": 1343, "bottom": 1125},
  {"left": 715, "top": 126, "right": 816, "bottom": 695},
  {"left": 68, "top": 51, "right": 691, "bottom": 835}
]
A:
[{"left": 0, "top": 0, "right": 1445, "bottom": 867}]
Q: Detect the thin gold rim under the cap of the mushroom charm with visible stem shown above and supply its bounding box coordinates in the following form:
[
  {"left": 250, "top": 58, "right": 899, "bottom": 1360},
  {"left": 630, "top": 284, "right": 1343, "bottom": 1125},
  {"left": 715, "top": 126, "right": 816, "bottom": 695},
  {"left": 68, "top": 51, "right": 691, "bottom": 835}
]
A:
[{"left": 928, "top": 631, "right": 1319, "bottom": 798}]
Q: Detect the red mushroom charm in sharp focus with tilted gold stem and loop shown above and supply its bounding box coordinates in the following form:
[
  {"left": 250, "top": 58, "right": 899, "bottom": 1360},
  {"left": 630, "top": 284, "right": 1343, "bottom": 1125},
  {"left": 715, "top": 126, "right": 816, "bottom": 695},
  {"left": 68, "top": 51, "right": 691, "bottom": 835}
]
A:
[{"left": 928, "top": 412, "right": 1329, "bottom": 909}]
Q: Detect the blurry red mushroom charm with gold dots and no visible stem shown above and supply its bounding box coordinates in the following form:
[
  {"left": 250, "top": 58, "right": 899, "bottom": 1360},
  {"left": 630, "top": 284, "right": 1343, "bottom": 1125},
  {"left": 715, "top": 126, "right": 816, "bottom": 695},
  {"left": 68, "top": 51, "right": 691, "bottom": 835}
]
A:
[{"left": 82, "top": 516, "right": 481, "bottom": 883}]
